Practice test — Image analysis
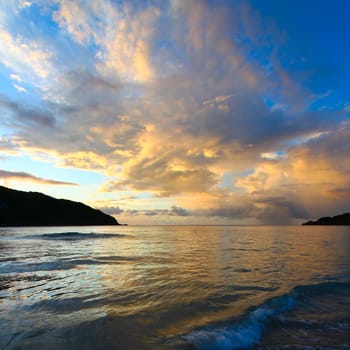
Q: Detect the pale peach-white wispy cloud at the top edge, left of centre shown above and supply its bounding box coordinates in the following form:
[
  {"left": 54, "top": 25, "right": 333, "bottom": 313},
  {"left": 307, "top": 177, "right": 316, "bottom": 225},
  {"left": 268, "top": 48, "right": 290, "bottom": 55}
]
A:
[{"left": 53, "top": 0, "right": 160, "bottom": 82}]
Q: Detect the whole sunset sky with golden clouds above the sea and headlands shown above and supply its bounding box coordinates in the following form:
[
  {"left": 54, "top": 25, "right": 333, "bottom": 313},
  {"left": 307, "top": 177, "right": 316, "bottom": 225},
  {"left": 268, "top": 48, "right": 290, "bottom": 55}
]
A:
[{"left": 0, "top": 0, "right": 350, "bottom": 225}]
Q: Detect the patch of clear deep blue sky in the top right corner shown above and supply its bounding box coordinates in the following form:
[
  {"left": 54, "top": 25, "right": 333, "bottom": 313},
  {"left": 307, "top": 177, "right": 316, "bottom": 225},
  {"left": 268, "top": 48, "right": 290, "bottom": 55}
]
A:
[{"left": 251, "top": 0, "right": 350, "bottom": 103}]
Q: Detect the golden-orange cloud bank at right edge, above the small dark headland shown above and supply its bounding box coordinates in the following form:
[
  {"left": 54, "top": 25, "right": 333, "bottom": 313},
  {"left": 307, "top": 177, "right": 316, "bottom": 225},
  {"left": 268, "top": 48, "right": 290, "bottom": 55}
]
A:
[{"left": 235, "top": 126, "right": 350, "bottom": 218}]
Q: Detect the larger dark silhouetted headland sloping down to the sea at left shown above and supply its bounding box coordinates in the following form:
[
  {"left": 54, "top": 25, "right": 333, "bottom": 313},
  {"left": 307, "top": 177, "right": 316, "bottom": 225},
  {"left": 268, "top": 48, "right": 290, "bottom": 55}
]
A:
[{"left": 0, "top": 186, "right": 119, "bottom": 226}]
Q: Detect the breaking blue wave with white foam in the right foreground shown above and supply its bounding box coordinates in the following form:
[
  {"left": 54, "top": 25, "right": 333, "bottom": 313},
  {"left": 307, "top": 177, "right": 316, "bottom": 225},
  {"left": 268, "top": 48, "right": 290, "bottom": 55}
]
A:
[{"left": 182, "top": 282, "right": 350, "bottom": 350}]
